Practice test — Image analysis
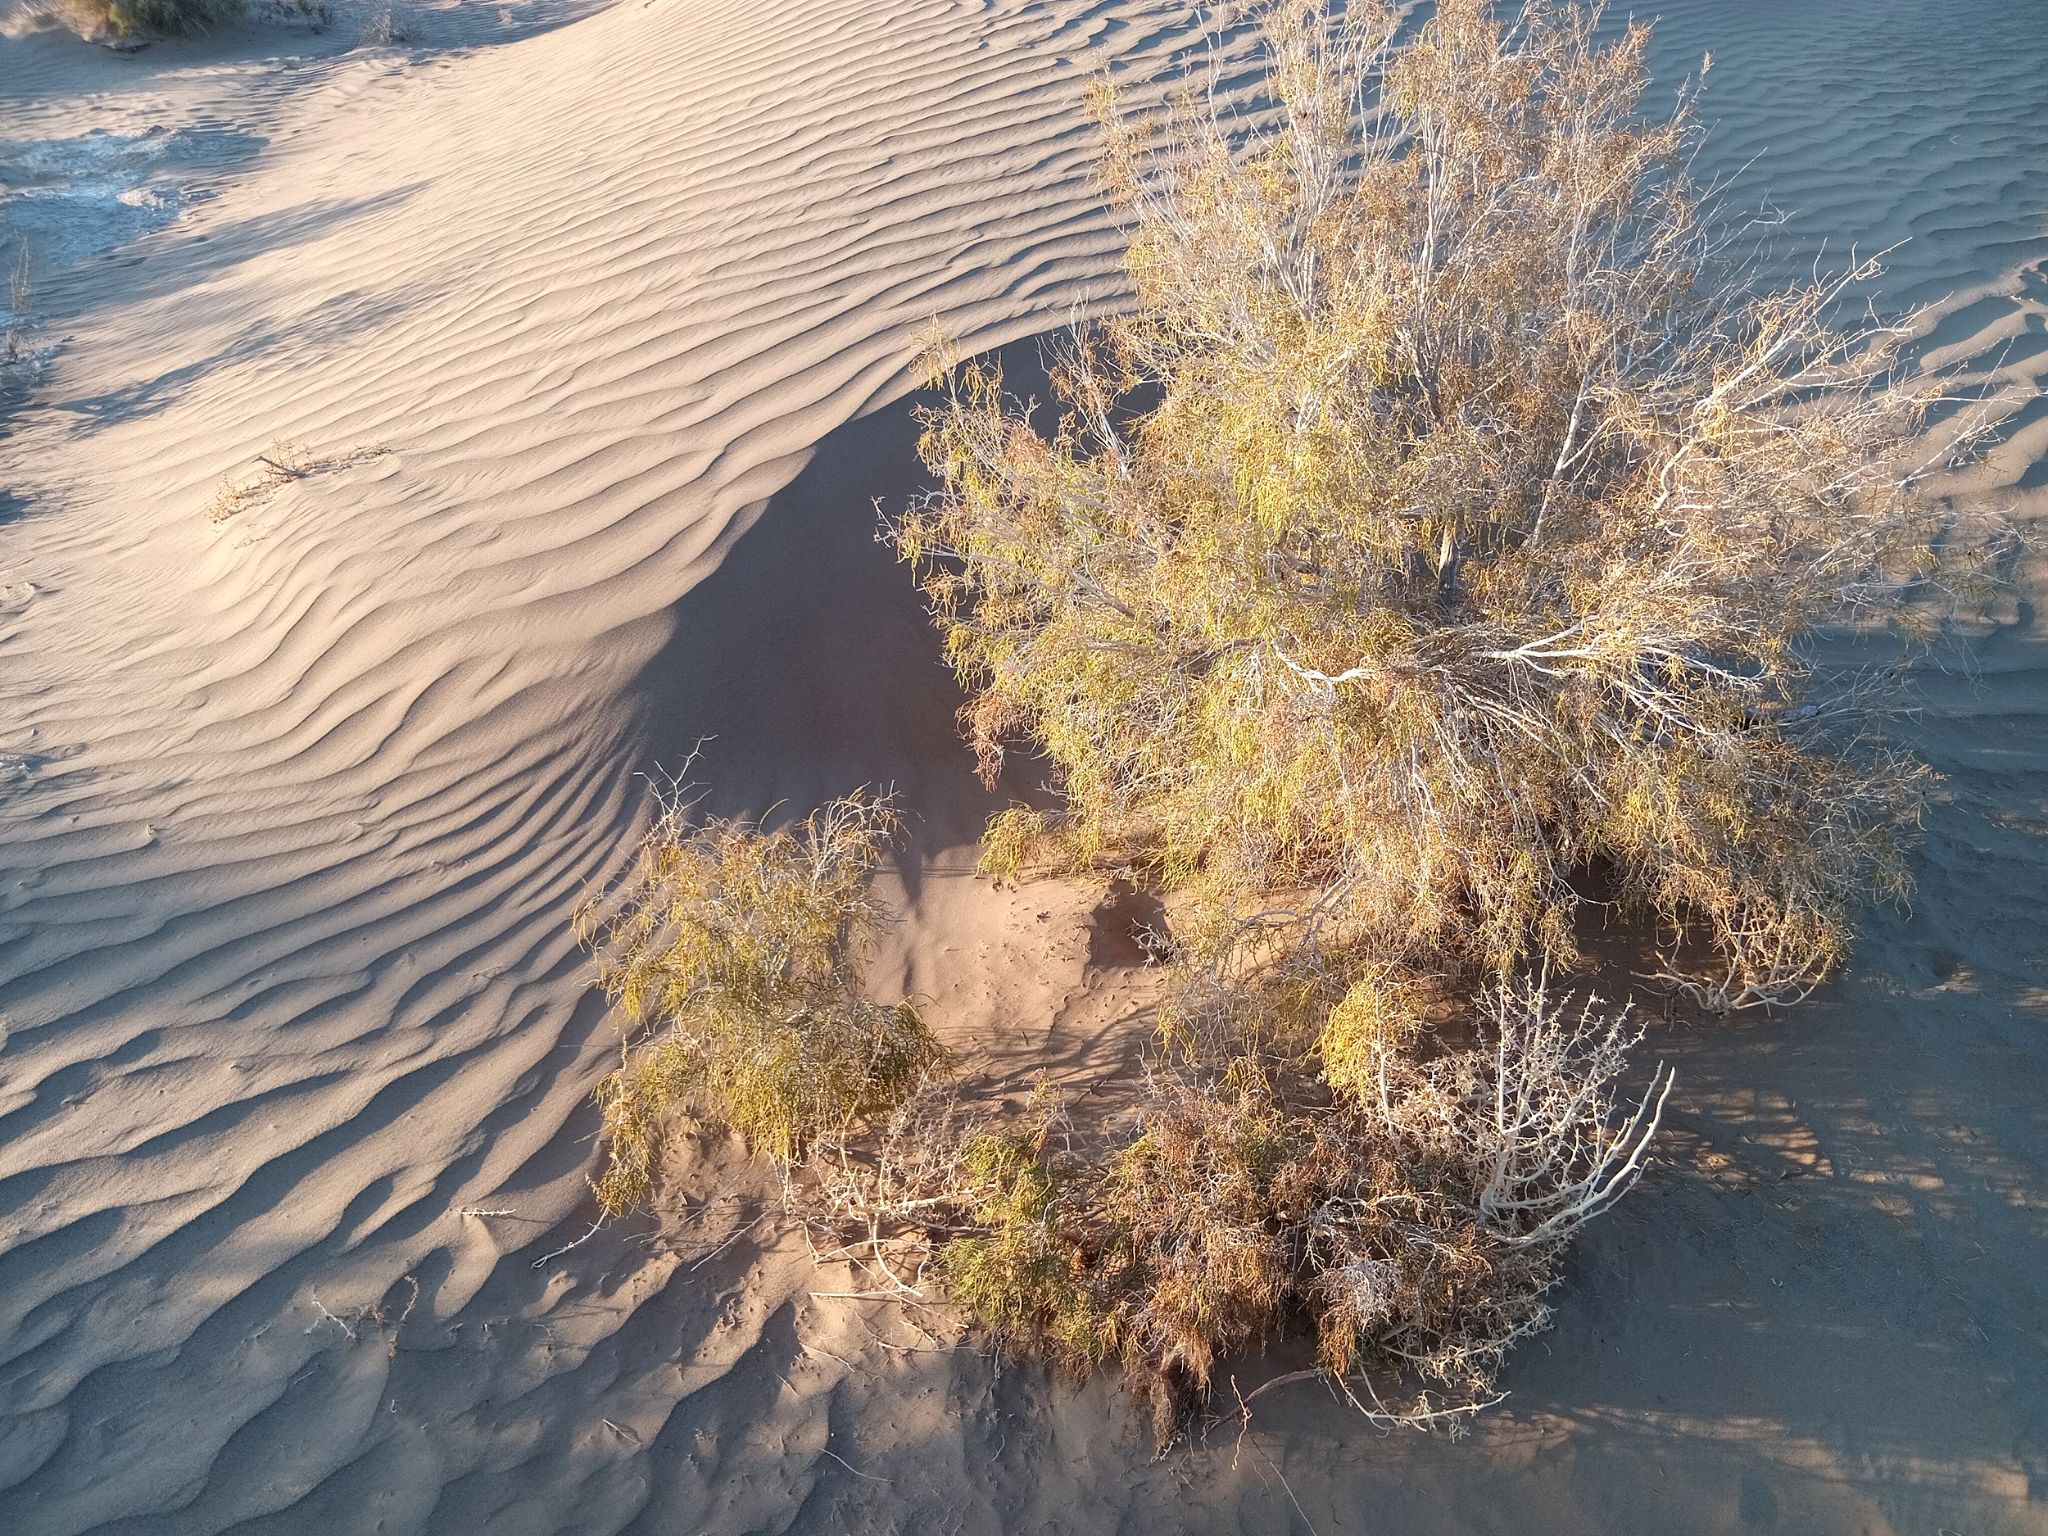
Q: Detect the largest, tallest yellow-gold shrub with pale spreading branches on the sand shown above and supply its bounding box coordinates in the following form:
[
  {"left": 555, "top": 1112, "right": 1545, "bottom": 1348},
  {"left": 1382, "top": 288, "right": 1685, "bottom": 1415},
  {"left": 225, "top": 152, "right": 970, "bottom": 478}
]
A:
[{"left": 895, "top": 0, "right": 1978, "bottom": 1018}]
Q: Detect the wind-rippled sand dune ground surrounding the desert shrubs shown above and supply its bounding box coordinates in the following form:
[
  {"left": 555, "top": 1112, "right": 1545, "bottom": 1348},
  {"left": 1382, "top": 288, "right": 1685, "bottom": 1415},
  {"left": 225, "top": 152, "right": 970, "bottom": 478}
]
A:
[{"left": 0, "top": 0, "right": 2048, "bottom": 1536}]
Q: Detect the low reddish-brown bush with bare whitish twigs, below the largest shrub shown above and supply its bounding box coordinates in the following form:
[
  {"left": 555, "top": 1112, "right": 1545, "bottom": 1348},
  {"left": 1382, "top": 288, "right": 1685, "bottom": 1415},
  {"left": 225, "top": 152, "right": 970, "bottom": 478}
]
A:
[{"left": 940, "top": 987, "right": 1671, "bottom": 1440}]
